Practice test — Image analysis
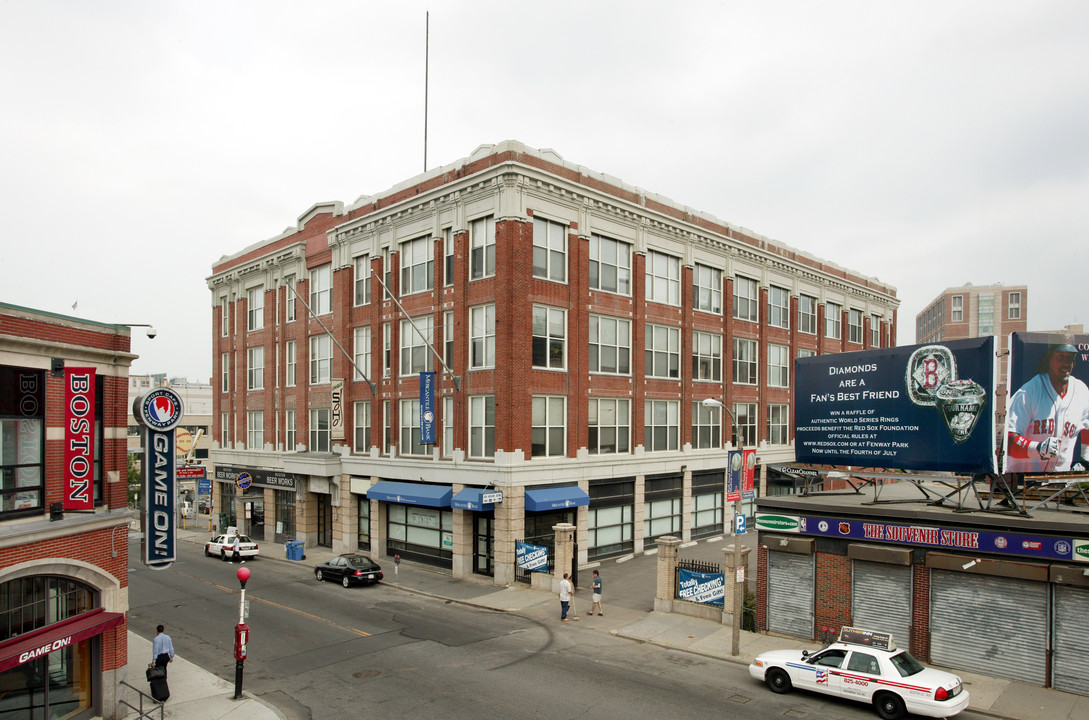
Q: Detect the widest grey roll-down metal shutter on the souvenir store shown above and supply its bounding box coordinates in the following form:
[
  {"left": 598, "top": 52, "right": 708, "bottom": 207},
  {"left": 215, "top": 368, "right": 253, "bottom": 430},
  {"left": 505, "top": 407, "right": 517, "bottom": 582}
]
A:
[{"left": 930, "top": 570, "right": 1048, "bottom": 685}]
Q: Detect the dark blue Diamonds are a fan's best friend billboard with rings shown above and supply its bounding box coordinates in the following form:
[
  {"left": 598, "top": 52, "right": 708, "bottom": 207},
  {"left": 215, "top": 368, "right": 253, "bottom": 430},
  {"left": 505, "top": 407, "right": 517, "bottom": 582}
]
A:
[{"left": 794, "top": 337, "right": 998, "bottom": 473}]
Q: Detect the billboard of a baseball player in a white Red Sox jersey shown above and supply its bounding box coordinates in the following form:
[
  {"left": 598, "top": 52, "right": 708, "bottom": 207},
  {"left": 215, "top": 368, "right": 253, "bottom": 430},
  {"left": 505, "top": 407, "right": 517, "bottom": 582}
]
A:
[{"left": 1004, "top": 332, "right": 1089, "bottom": 474}]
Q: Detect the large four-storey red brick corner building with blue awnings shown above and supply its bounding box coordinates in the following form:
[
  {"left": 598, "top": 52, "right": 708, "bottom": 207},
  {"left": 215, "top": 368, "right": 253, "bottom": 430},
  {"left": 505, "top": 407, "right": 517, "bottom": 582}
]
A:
[{"left": 208, "top": 142, "right": 898, "bottom": 584}]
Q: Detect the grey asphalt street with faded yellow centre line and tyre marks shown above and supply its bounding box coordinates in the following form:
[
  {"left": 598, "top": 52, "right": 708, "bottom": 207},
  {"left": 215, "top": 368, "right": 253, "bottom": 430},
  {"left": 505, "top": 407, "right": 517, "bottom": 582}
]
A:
[{"left": 129, "top": 542, "right": 988, "bottom": 720}]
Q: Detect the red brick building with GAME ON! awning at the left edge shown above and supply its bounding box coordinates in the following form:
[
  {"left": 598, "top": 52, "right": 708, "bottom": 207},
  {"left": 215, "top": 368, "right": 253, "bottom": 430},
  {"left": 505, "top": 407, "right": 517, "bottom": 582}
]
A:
[{"left": 0, "top": 304, "right": 135, "bottom": 718}]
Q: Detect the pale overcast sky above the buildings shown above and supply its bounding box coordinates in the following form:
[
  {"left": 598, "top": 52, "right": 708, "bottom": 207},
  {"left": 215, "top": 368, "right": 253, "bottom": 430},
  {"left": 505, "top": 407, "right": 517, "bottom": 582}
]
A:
[{"left": 0, "top": 0, "right": 1089, "bottom": 380}]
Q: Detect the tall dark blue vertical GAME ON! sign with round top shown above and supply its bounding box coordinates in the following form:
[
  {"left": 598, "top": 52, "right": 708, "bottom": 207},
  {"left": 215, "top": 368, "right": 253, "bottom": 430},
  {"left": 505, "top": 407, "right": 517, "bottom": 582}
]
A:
[{"left": 133, "top": 388, "right": 182, "bottom": 570}]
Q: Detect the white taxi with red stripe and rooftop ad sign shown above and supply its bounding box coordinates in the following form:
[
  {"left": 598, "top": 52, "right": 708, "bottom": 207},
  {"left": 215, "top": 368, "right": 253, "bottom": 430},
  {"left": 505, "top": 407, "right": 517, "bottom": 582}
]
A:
[{"left": 749, "top": 627, "right": 968, "bottom": 720}]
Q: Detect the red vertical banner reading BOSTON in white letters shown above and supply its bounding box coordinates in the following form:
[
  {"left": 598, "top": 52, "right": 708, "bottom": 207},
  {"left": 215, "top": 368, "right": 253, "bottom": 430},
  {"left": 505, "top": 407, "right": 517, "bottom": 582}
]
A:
[{"left": 63, "top": 367, "right": 95, "bottom": 510}]
